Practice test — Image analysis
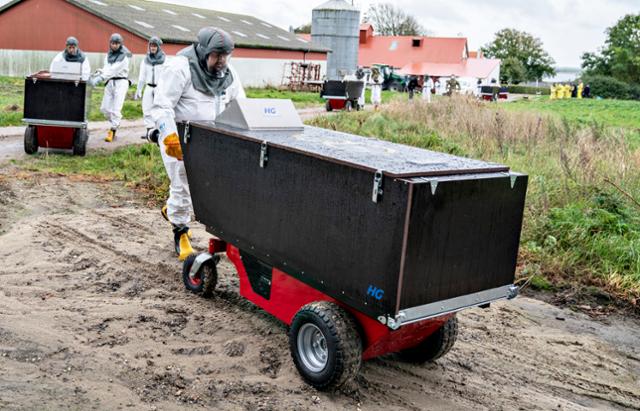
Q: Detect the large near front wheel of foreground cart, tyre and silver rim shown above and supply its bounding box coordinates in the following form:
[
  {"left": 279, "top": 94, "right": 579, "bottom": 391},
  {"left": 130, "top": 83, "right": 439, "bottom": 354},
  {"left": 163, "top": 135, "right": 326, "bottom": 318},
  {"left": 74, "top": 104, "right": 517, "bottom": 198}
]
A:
[{"left": 289, "top": 301, "right": 362, "bottom": 390}]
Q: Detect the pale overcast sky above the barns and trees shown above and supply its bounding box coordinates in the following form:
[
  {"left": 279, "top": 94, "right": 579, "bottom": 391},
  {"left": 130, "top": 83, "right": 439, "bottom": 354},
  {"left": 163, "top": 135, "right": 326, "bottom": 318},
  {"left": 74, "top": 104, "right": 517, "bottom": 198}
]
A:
[{"left": 150, "top": 0, "right": 640, "bottom": 67}]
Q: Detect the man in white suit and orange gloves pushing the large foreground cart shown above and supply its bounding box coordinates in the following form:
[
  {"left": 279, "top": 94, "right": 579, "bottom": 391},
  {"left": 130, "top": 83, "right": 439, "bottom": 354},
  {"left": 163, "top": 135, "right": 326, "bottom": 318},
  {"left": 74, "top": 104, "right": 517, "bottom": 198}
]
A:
[{"left": 151, "top": 27, "right": 246, "bottom": 261}]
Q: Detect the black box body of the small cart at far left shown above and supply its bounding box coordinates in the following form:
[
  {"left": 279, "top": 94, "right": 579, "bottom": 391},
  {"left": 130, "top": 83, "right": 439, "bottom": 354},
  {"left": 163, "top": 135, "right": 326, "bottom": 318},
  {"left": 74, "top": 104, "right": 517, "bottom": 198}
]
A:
[{"left": 24, "top": 75, "right": 90, "bottom": 123}]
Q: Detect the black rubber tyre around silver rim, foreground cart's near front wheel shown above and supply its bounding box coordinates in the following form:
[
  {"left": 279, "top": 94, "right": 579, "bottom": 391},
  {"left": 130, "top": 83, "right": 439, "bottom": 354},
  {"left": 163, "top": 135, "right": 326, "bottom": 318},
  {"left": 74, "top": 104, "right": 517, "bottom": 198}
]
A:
[{"left": 289, "top": 301, "right": 362, "bottom": 390}]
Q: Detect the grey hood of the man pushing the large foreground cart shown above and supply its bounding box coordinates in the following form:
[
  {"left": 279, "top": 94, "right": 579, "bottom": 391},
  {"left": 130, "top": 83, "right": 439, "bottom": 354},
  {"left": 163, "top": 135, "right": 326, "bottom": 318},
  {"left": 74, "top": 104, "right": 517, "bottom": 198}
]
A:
[{"left": 178, "top": 27, "right": 234, "bottom": 96}]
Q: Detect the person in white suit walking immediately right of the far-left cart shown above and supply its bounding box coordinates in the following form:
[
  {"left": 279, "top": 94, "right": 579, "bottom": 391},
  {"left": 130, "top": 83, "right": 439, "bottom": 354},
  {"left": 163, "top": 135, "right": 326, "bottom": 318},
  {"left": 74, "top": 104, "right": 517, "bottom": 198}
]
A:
[{"left": 90, "top": 33, "right": 131, "bottom": 143}]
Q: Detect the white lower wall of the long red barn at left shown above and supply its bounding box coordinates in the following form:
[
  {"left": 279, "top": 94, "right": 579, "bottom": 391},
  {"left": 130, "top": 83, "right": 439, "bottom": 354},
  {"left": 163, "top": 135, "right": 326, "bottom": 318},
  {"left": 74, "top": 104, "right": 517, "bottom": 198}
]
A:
[{"left": 0, "top": 50, "right": 327, "bottom": 87}]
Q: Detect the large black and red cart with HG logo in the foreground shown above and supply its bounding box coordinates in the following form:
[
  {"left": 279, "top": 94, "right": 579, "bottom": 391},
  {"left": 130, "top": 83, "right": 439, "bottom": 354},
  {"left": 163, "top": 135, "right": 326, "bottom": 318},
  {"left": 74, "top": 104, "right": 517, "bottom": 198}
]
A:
[{"left": 180, "top": 102, "right": 527, "bottom": 389}]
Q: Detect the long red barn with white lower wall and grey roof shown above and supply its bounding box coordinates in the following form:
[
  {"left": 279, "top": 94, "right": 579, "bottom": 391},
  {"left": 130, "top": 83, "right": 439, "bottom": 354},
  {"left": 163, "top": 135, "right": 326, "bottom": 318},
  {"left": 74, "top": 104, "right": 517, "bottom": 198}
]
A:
[{"left": 0, "top": 0, "right": 328, "bottom": 86}]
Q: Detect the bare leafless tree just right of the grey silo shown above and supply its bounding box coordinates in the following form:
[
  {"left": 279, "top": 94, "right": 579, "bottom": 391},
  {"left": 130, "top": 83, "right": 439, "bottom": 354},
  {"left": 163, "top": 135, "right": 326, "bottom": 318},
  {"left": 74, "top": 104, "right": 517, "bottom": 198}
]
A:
[{"left": 364, "top": 3, "right": 425, "bottom": 36}]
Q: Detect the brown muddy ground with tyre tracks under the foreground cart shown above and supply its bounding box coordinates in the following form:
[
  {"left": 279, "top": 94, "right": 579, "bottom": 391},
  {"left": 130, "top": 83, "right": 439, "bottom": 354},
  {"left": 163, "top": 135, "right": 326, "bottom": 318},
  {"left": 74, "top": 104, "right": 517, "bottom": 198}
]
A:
[{"left": 0, "top": 167, "right": 640, "bottom": 410}]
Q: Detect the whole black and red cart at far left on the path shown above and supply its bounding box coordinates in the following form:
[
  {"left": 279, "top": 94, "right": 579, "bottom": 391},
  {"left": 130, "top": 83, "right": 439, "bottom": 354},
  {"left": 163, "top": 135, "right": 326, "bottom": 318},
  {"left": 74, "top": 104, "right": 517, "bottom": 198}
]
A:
[{"left": 23, "top": 72, "right": 91, "bottom": 156}]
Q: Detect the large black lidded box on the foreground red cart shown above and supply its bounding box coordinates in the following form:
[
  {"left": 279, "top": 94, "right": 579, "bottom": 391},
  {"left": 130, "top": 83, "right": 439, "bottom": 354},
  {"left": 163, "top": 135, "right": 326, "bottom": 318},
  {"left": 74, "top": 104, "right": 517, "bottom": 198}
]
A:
[{"left": 181, "top": 123, "right": 527, "bottom": 318}]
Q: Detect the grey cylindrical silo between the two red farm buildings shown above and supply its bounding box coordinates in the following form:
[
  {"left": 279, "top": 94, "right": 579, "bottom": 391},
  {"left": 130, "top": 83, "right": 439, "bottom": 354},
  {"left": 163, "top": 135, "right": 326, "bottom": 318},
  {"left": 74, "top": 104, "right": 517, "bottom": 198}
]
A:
[{"left": 311, "top": 0, "right": 360, "bottom": 80}]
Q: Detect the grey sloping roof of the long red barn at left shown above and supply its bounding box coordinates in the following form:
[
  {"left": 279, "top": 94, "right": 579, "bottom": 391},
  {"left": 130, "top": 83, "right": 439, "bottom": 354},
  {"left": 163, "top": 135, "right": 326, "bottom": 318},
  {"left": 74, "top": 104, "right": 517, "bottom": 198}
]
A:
[{"left": 0, "top": 0, "right": 329, "bottom": 52}]
